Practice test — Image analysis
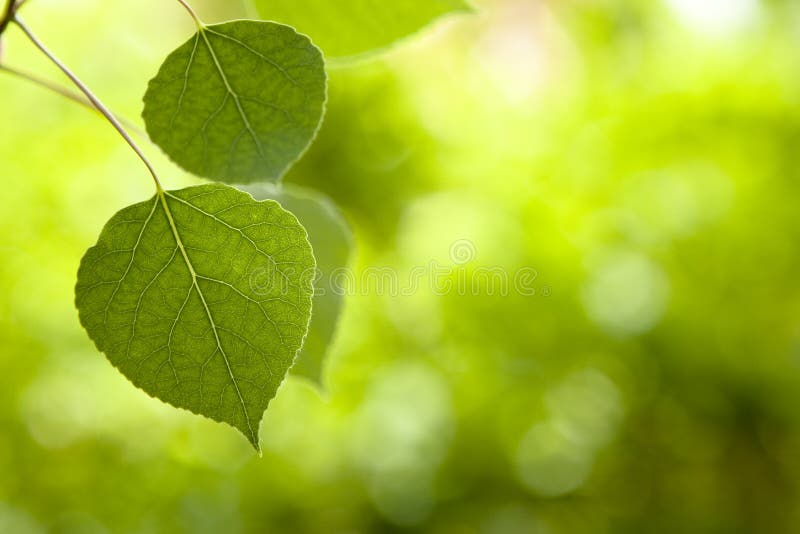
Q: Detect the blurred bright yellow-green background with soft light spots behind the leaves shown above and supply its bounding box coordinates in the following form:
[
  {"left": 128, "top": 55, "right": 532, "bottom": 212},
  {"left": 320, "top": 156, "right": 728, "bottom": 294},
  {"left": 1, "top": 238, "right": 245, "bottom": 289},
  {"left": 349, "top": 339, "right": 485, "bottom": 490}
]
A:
[{"left": 0, "top": 0, "right": 800, "bottom": 534}]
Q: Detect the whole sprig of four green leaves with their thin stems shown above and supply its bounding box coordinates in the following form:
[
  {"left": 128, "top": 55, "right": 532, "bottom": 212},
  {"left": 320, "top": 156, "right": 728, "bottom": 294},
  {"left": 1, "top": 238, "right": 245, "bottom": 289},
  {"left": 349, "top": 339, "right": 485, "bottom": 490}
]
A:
[{"left": 0, "top": 0, "right": 470, "bottom": 460}]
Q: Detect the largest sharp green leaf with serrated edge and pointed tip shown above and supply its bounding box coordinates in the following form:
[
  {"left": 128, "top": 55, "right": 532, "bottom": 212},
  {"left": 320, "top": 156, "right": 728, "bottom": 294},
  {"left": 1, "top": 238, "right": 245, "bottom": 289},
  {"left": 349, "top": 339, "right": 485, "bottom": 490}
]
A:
[{"left": 75, "top": 184, "right": 315, "bottom": 449}]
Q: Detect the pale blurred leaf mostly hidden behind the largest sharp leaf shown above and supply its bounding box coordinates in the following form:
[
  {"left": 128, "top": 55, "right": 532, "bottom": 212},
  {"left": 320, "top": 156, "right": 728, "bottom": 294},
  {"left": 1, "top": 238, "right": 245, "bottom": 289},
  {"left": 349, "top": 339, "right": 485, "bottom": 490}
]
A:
[{"left": 244, "top": 184, "right": 353, "bottom": 386}]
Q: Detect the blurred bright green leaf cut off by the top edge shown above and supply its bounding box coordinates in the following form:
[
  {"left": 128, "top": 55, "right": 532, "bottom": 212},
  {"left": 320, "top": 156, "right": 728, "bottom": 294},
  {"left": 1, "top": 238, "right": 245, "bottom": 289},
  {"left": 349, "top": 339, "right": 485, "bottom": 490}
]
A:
[{"left": 253, "top": 0, "right": 472, "bottom": 58}]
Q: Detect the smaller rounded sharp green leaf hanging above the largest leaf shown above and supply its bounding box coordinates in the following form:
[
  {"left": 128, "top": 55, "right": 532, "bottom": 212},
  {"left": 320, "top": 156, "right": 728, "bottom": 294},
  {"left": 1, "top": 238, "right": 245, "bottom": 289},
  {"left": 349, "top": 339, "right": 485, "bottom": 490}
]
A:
[{"left": 142, "top": 20, "right": 327, "bottom": 183}]
